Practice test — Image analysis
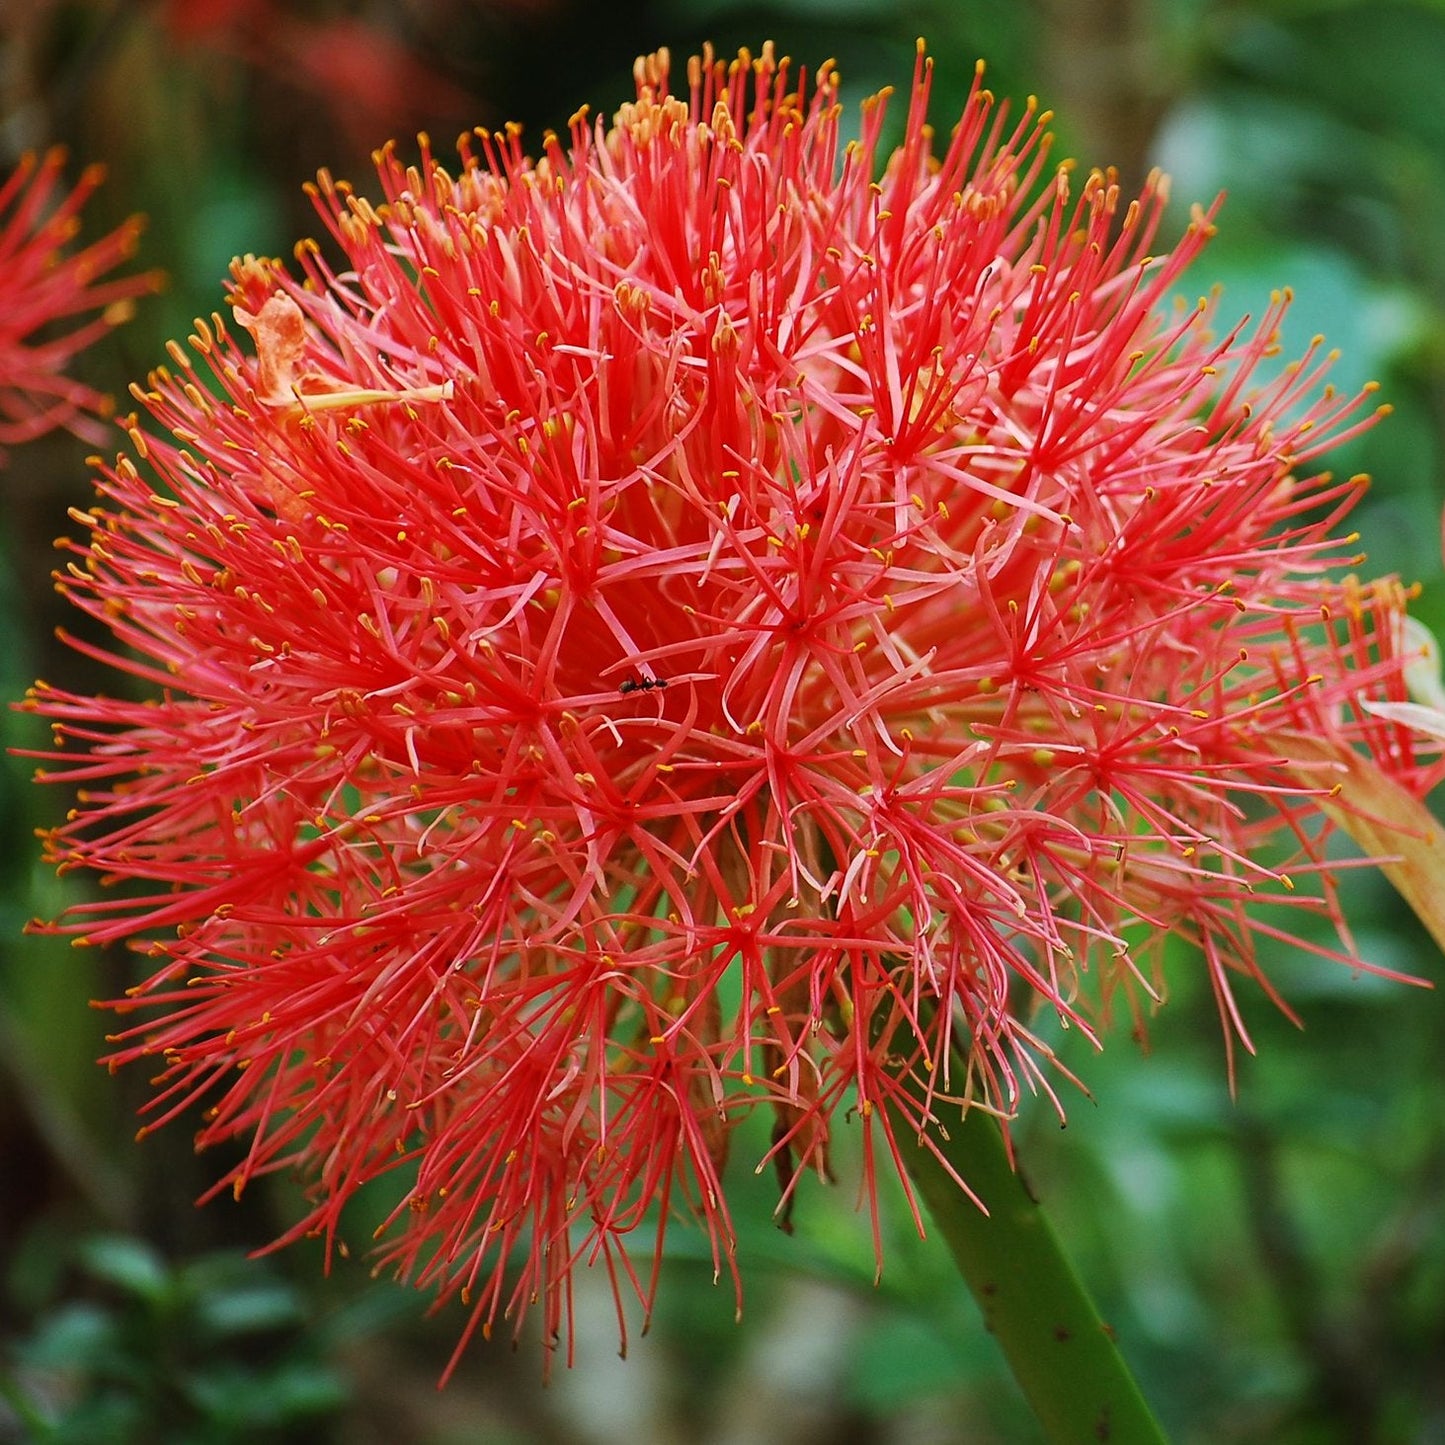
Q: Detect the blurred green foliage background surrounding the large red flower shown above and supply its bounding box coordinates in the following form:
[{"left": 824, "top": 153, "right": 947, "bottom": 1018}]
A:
[{"left": 0, "top": 0, "right": 1445, "bottom": 1445}]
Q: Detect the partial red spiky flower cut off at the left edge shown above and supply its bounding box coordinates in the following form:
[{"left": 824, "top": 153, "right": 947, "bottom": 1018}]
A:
[{"left": 0, "top": 149, "right": 158, "bottom": 455}]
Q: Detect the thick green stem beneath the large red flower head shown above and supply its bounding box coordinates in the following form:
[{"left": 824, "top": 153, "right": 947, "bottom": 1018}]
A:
[{"left": 893, "top": 1108, "right": 1165, "bottom": 1445}]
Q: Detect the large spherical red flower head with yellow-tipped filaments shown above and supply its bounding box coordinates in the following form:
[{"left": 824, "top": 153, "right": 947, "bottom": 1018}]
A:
[{"left": 32, "top": 48, "right": 1439, "bottom": 1364}]
